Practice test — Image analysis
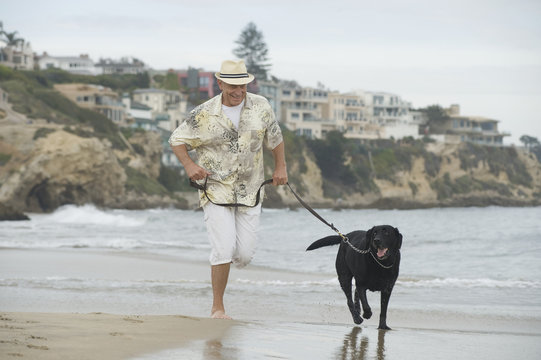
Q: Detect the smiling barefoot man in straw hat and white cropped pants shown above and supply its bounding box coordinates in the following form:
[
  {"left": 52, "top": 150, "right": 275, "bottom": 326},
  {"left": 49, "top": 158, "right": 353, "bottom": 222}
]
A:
[{"left": 169, "top": 60, "right": 287, "bottom": 319}]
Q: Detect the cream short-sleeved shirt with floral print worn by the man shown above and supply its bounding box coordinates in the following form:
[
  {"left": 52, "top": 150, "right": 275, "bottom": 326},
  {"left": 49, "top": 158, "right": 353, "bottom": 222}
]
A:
[{"left": 169, "top": 93, "right": 283, "bottom": 209}]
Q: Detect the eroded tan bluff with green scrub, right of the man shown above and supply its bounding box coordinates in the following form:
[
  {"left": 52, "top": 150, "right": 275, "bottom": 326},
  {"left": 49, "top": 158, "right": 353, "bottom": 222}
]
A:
[{"left": 267, "top": 133, "right": 541, "bottom": 209}]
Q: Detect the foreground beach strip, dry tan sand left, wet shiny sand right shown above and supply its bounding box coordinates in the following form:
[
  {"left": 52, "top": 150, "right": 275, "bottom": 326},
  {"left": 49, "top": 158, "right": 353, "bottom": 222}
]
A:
[{"left": 0, "top": 312, "right": 541, "bottom": 360}]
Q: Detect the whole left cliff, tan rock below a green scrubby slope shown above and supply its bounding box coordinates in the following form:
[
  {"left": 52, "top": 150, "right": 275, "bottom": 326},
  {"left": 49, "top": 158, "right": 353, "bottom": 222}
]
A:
[{"left": 0, "top": 69, "right": 188, "bottom": 212}]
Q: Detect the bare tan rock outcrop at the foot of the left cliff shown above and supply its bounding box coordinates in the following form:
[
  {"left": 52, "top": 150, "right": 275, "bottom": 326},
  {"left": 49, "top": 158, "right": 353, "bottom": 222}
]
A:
[{"left": 0, "top": 112, "right": 186, "bottom": 212}]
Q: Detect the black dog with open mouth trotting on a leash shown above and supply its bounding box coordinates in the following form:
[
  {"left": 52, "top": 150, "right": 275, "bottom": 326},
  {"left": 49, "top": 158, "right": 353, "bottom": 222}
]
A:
[{"left": 306, "top": 225, "right": 402, "bottom": 330}]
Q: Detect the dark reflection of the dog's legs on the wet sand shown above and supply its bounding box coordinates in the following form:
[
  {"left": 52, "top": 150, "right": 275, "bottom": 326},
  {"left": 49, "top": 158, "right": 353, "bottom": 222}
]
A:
[{"left": 337, "top": 326, "right": 386, "bottom": 360}]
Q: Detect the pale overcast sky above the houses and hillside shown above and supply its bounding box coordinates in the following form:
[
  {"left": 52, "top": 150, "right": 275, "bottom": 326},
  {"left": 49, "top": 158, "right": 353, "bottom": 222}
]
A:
[{"left": 0, "top": 0, "right": 541, "bottom": 144}]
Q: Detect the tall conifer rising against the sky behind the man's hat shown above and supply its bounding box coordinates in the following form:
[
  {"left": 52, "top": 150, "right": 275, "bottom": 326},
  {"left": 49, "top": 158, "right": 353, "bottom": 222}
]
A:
[{"left": 233, "top": 22, "right": 271, "bottom": 80}]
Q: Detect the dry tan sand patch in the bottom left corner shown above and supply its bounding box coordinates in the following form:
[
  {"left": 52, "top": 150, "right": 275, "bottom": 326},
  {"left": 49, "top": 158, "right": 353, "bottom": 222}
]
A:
[{"left": 0, "top": 313, "right": 232, "bottom": 360}]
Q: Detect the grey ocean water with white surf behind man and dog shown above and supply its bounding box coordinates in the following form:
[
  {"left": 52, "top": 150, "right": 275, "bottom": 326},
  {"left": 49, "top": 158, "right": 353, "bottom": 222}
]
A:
[{"left": 0, "top": 205, "right": 541, "bottom": 322}]
